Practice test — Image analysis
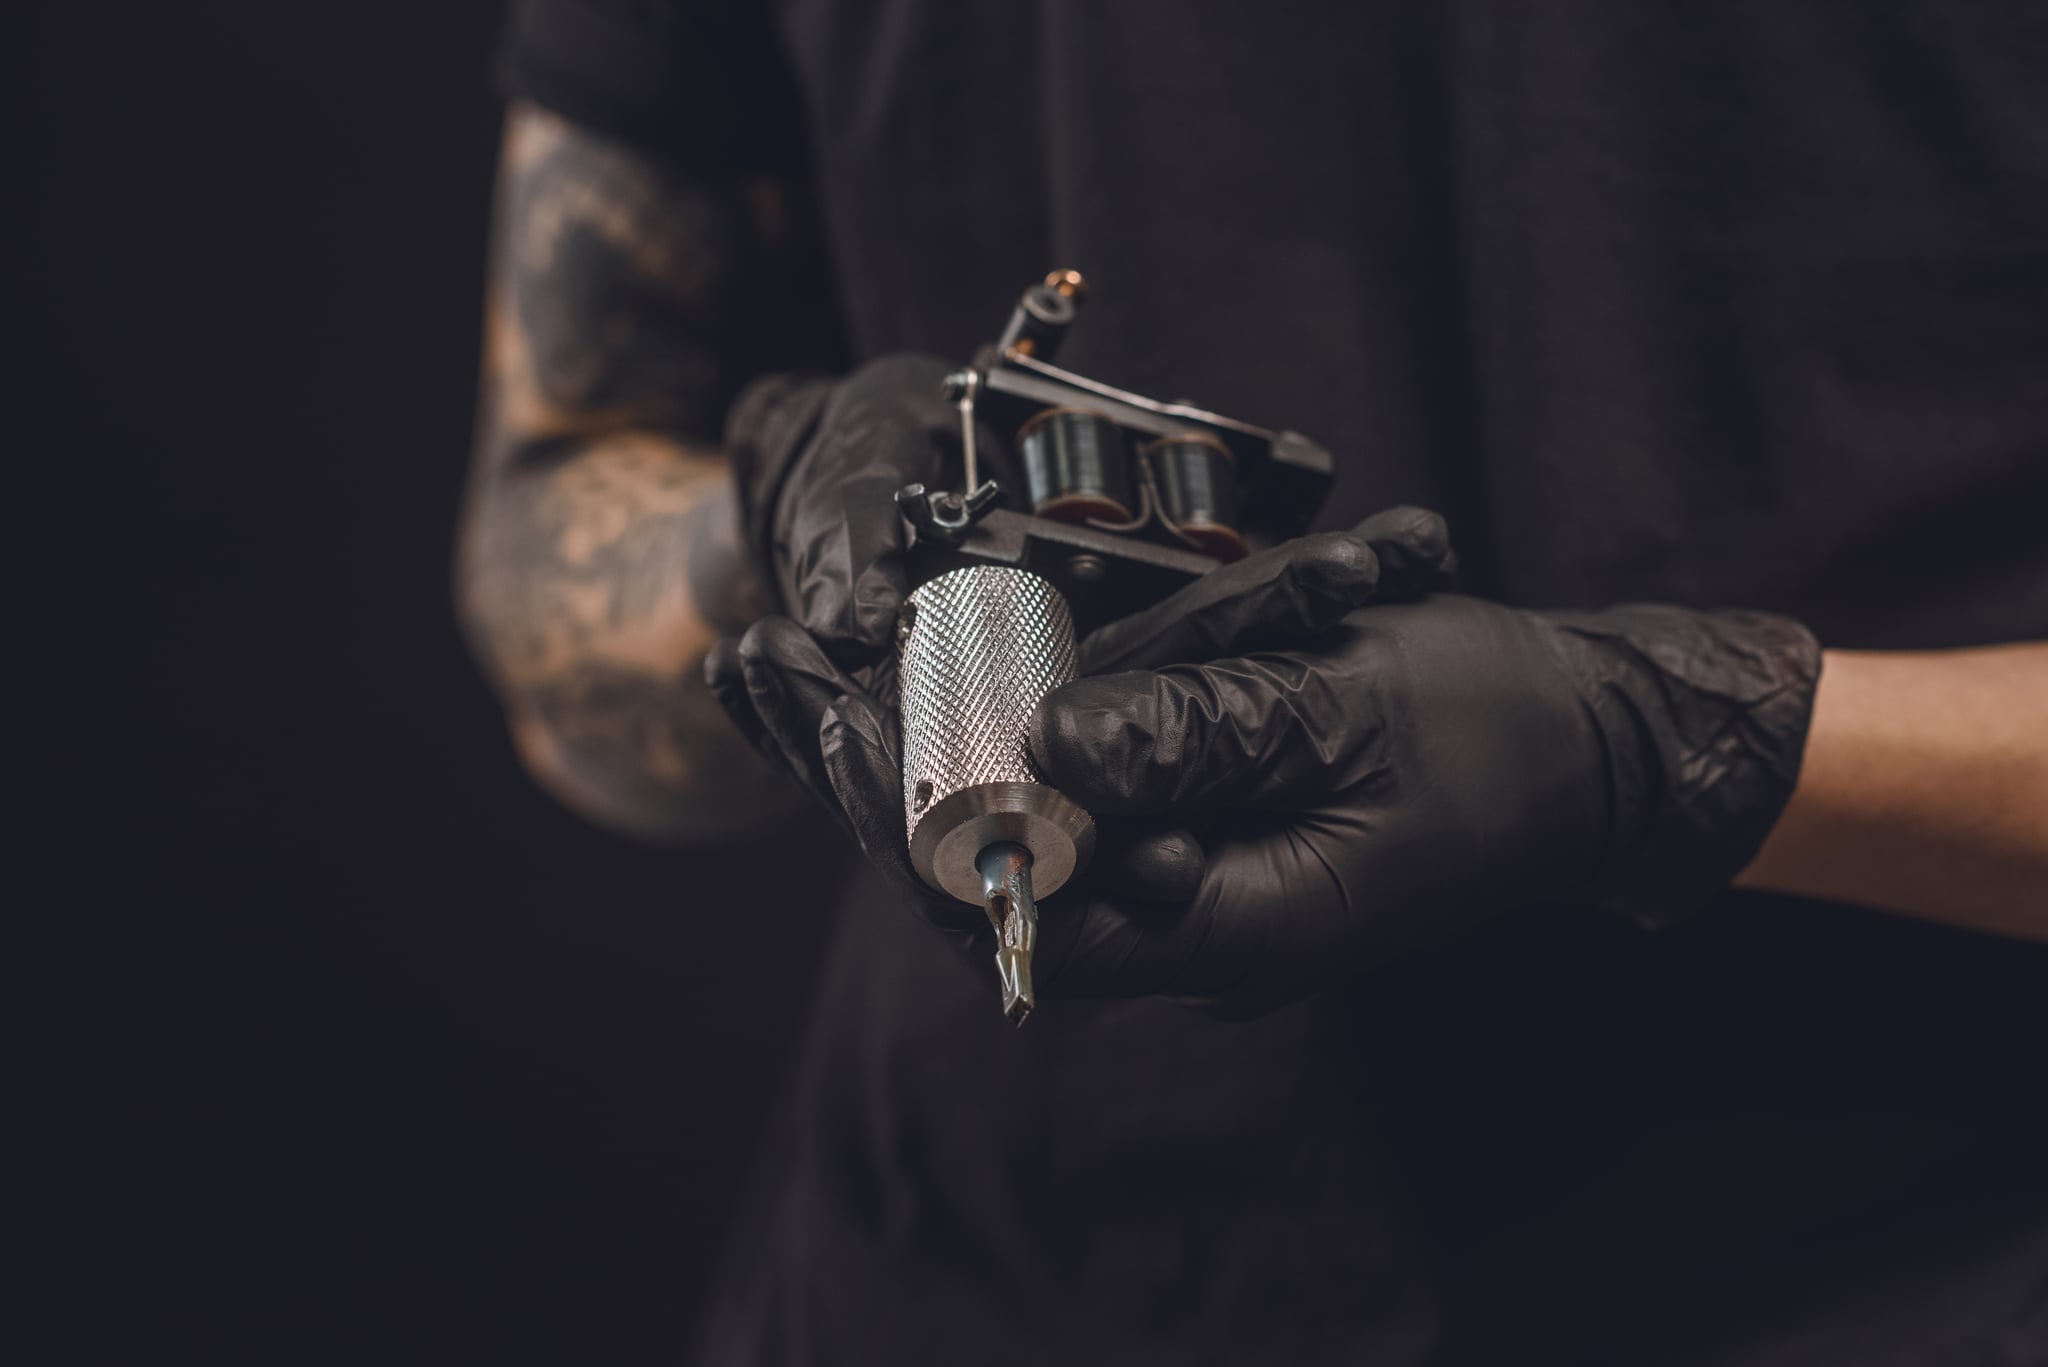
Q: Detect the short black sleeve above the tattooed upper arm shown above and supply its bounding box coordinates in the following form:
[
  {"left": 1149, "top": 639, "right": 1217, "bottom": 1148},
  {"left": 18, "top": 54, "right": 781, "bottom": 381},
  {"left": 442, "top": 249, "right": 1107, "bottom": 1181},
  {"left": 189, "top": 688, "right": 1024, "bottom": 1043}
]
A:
[{"left": 498, "top": 0, "right": 805, "bottom": 176}]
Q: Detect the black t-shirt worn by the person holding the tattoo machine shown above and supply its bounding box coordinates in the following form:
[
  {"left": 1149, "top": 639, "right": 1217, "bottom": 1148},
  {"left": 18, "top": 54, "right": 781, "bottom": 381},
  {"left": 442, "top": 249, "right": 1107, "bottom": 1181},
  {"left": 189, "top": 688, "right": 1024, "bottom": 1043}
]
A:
[{"left": 506, "top": 0, "right": 2048, "bottom": 1367}]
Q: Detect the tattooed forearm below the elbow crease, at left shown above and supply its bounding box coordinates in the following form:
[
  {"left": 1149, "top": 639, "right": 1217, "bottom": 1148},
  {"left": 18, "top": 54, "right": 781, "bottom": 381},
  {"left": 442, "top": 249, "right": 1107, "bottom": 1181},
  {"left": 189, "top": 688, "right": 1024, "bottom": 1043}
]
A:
[{"left": 463, "top": 432, "right": 788, "bottom": 838}]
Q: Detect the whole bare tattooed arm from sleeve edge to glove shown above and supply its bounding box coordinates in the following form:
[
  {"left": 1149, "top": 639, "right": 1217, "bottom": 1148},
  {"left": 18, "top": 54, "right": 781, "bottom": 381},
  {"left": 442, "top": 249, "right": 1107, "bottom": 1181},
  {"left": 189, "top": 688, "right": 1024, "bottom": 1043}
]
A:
[{"left": 461, "top": 109, "right": 829, "bottom": 836}]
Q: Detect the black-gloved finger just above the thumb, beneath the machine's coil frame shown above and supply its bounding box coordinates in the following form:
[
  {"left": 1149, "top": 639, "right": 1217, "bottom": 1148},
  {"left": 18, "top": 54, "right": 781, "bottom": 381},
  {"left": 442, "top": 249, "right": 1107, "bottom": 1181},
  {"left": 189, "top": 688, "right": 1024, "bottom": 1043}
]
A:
[{"left": 1081, "top": 531, "right": 1380, "bottom": 674}]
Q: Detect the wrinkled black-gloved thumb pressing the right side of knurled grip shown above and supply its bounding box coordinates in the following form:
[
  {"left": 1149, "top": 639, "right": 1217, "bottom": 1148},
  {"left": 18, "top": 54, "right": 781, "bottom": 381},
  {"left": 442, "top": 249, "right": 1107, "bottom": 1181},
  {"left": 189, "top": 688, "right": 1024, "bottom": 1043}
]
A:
[{"left": 1030, "top": 654, "right": 1384, "bottom": 816}]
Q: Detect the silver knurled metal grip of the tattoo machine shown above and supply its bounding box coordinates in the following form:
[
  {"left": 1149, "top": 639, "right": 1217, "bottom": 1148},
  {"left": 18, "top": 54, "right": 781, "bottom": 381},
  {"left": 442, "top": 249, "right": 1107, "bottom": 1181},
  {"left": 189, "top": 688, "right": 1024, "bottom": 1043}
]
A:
[{"left": 897, "top": 566, "right": 1096, "bottom": 906}]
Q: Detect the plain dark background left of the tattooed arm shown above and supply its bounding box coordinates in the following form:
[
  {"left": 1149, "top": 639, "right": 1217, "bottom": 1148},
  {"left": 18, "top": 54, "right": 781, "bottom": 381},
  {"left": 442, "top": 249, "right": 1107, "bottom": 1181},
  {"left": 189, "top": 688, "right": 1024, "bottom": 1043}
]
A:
[{"left": 16, "top": 0, "right": 827, "bottom": 1363}]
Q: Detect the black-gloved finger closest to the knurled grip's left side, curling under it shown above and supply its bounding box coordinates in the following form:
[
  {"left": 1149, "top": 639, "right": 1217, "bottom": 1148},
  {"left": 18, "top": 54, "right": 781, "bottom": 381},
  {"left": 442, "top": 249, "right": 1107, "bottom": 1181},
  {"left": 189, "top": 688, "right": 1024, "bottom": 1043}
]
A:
[{"left": 819, "top": 693, "right": 987, "bottom": 933}]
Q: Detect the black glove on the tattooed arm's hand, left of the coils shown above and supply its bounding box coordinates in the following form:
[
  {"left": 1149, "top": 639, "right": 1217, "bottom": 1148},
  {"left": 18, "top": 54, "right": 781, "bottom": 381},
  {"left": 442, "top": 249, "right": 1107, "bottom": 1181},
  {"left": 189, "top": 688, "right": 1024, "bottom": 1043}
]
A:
[{"left": 725, "top": 355, "right": 1001, "bottom": 666}]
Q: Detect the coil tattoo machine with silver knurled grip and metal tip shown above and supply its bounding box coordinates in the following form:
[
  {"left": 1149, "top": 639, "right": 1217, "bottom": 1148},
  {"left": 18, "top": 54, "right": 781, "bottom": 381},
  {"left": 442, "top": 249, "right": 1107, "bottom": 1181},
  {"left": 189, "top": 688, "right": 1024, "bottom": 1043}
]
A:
[{"left": 897, "top": 271, "right": 1331, "bottom": 1023}]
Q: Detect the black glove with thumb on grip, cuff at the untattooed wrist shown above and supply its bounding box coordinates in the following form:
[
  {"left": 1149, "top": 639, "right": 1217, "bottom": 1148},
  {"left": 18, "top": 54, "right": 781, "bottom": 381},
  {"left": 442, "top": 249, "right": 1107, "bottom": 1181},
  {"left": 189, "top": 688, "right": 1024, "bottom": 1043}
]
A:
[{"left": 1032, "top": 594, "right": 1819, "bottom": 1014}]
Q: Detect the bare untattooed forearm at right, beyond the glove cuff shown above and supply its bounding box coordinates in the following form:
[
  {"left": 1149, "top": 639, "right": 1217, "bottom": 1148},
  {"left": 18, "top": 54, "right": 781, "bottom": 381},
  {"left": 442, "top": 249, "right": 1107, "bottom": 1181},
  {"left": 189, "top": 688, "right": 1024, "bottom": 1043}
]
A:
[{"left": 1739, "top": 644, "right": 2048, "bottom": 939}]
